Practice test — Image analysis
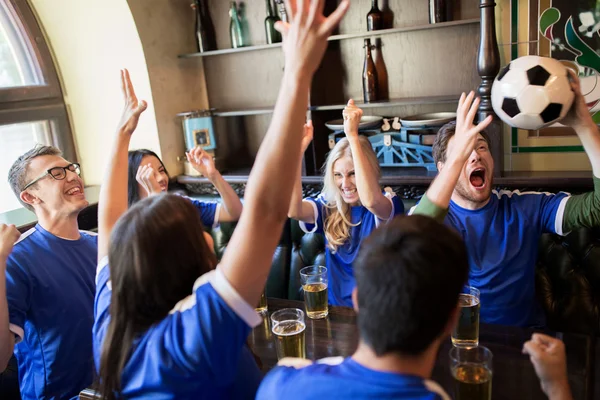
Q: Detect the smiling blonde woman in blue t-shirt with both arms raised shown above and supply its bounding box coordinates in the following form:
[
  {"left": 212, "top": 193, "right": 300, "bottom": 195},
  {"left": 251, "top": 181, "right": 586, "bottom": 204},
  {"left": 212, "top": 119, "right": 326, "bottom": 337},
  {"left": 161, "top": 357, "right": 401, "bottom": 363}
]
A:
[{"left": 288, "top": 100, "right": 404, "bottom": 307}]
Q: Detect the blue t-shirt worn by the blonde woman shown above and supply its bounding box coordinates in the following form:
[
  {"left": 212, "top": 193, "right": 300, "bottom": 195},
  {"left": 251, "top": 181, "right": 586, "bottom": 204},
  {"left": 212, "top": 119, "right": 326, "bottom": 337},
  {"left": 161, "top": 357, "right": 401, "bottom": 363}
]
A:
[{"left": 300, "top": 191, "right": 404, "bottom": 307}]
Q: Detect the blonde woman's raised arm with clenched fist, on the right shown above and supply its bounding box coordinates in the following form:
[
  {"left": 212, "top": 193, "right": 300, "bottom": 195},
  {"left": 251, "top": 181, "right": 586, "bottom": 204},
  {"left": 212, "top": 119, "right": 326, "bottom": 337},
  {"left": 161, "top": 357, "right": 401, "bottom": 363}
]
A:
[{"left": 342, "top": 99, "right": 392, "bottom": 220}]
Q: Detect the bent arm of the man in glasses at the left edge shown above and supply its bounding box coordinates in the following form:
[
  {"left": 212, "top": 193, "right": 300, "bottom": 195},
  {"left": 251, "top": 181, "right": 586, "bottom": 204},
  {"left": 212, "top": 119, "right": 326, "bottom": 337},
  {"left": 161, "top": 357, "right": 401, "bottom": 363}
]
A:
[{"left": 0, "top": 224, "right": 21, "bottom": 372}]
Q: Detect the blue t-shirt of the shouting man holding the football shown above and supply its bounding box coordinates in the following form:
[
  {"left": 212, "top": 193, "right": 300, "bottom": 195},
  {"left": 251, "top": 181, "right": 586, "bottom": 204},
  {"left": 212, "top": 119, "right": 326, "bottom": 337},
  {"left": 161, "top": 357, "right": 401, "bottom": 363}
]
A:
[{"left": 445, "top": 190, "right": 569, "bottom": 326}]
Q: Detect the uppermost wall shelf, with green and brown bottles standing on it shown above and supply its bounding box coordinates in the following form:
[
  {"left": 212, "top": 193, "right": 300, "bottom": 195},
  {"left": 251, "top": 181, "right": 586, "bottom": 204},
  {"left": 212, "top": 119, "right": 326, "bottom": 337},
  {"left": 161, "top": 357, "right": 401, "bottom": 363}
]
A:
[{"left": 178, "top": 18, "right": 479, "bottom": 58}]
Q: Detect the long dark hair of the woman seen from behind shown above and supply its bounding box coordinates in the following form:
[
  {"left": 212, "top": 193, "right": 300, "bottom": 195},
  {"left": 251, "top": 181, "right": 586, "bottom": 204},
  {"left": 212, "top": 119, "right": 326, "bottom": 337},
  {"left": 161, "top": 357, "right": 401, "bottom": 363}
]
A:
[{"left": 98, "top": 194, "right": 217, "bottom": 400}]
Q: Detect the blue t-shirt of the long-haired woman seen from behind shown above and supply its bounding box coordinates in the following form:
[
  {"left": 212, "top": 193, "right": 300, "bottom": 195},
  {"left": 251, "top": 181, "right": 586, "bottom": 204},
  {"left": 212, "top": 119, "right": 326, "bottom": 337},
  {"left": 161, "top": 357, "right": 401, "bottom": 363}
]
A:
[{"left": 93, "top": 258, "right": 262, "bottom": 400}]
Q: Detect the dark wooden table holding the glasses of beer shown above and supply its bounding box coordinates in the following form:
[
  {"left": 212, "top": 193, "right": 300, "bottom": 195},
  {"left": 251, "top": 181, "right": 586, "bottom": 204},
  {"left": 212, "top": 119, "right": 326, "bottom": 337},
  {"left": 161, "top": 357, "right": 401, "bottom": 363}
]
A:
[{"left": 249, "top": 298, "right": 596, "bottom": 400}]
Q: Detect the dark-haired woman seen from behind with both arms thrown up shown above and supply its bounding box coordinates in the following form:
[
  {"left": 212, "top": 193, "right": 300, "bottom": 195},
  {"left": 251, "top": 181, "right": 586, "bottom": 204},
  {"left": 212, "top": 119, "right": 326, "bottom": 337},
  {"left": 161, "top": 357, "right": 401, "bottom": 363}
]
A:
[{"left": 93, "top": 0, "right": 348, "bottom": 399}]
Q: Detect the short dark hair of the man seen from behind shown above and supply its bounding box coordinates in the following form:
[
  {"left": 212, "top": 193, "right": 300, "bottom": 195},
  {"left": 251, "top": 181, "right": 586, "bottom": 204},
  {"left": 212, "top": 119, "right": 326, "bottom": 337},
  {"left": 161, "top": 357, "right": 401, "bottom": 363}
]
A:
[{"left": 354, "top": 215, "right": 469, "bottom": 356}]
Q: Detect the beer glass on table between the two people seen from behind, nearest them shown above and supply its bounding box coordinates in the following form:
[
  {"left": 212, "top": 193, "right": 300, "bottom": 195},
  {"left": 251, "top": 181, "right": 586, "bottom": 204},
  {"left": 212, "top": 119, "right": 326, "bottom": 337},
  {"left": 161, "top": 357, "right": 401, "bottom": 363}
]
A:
[{"left": 271, "top": 308, "right": 306, "bottom": 360}]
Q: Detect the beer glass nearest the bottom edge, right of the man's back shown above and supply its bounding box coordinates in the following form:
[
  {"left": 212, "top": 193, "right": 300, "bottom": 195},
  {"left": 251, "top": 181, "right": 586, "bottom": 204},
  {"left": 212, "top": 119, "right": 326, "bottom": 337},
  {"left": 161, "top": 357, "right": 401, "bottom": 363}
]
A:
[{"left": 450, "top": 346, "right": 492, "bottom": 400}]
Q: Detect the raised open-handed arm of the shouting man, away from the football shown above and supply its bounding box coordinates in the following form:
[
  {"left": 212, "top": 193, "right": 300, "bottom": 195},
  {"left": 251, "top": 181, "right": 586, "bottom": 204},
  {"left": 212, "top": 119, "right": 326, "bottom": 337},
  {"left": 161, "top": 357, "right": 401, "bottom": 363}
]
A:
[{"left": 412, "top": 92, "right": 492, "bottom": 219}]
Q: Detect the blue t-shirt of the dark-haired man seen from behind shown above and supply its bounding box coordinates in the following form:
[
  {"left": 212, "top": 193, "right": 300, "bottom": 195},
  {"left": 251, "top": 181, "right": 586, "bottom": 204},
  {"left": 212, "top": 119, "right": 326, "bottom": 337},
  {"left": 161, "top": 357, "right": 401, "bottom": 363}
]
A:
[{"left": 256, "top": 358, "right": 449, "bottom": 400}]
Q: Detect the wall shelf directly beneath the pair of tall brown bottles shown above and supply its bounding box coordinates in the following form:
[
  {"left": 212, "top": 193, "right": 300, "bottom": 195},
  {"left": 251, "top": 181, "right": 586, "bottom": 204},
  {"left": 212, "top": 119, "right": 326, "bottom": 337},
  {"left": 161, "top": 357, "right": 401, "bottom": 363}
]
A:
[{"left": 213, "top": 95, "right": 460, "bottom": 117}]
